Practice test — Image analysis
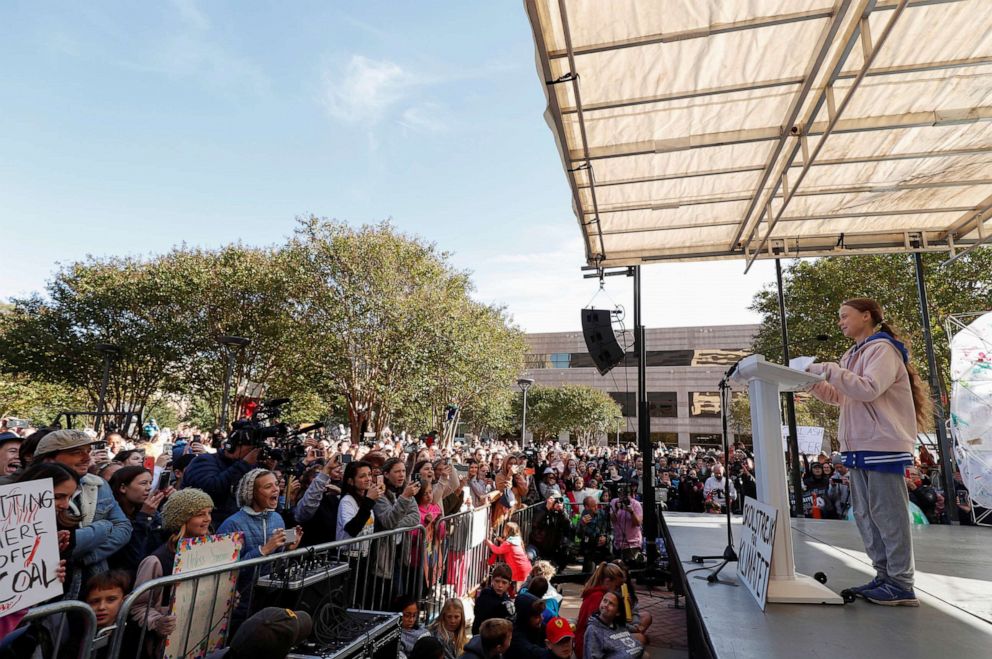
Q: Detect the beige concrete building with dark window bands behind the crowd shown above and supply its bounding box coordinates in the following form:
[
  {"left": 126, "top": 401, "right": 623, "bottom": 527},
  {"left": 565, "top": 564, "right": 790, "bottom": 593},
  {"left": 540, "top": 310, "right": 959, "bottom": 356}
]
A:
[{"left": 526, "top": 325, "right": 758, "bottom": 449}]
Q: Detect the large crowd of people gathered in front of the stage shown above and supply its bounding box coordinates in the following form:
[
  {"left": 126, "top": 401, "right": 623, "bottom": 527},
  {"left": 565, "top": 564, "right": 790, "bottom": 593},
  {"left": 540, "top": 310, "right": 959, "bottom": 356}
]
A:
[{"left": 0, "top": 408, "right": 976, "bottom": 659}]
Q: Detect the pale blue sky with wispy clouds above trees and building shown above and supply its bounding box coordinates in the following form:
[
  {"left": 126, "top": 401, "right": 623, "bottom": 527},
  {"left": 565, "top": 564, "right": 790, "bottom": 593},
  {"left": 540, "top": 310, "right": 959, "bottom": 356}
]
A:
[{"left": 0, "top": 0, "right": 773, "bottom": 331}]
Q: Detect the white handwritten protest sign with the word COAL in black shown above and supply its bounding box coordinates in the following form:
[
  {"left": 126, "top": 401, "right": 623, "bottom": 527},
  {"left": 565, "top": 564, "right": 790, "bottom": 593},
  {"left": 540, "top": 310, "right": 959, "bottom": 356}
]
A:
[{"left": 0, "top": 478, "right": 62, "bottom": 617}]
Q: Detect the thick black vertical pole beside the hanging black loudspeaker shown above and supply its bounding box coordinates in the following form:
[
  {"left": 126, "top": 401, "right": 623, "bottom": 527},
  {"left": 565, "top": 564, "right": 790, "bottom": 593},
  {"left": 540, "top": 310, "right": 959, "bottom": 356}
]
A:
[{"left": 633, "top": 265, "right": 658, "bottom": 570}]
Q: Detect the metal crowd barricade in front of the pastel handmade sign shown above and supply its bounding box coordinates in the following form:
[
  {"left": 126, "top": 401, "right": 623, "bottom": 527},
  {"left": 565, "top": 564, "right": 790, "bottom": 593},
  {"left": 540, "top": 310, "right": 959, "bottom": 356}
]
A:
[{"left": 106, "top": 526, "right": 426, "bottom": 659}]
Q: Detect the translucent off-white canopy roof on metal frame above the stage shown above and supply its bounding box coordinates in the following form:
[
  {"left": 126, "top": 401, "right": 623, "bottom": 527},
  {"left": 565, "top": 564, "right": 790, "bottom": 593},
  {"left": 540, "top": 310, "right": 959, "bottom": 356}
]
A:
[{"left": 525, "top": 0, "right": 992, "bottom": 267}]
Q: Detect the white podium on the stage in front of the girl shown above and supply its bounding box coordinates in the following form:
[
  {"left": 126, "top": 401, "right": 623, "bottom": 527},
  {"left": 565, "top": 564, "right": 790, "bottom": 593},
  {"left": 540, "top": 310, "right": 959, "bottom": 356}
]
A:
[{"left": 733, "top": 355, "right": 844, "bottom": 604}]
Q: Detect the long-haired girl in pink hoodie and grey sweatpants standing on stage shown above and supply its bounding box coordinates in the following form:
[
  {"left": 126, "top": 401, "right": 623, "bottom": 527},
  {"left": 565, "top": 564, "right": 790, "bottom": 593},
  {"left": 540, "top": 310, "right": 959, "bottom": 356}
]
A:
[{"left": 806, "top": 298, "right": 930, "bottom": 606}]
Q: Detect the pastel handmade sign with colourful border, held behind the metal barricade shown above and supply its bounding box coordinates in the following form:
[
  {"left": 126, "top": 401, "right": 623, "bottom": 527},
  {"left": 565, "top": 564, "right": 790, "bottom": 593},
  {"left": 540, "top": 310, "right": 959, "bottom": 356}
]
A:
[{"left": 165, "top": 532, "right": 244, "bottom": 659}]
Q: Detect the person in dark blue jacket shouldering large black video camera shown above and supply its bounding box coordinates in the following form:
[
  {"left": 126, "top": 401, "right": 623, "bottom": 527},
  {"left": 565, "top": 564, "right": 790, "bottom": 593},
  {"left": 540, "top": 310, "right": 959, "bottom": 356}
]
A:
[{"left": 183, "top": 433, "right": 261, "bottom": 527}]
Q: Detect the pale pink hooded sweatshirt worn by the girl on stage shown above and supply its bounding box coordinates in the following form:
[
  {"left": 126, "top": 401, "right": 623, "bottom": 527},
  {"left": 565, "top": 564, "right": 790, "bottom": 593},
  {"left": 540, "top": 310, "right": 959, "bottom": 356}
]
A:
[{"left": 808, "top": 340, "right": 916, "bottom": 453}]
